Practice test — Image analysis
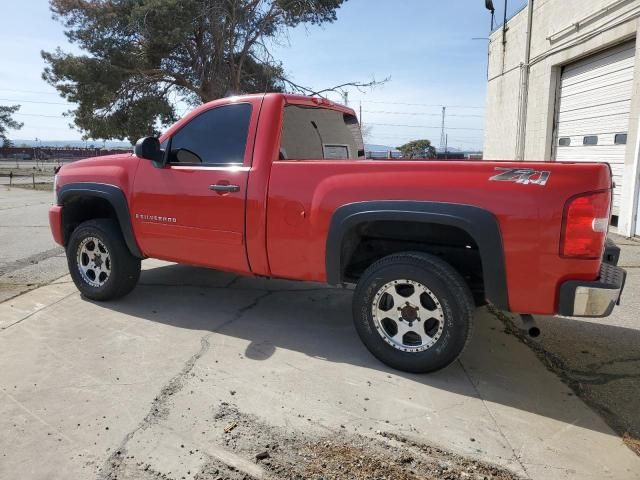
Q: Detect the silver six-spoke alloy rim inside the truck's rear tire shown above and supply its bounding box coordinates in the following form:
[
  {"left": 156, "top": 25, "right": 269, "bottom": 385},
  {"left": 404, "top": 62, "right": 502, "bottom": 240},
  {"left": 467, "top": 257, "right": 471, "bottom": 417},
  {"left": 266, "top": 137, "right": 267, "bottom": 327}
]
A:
[{"left": 371, "top": 279, "right": 444, "bottom": 352}]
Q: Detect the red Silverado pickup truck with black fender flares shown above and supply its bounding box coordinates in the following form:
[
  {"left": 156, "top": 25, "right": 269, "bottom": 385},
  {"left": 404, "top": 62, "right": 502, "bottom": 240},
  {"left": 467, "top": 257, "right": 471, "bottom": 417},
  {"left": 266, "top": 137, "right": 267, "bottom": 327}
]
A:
[{"left": 49, "top": 93, "right": 625, "bottom": 372}]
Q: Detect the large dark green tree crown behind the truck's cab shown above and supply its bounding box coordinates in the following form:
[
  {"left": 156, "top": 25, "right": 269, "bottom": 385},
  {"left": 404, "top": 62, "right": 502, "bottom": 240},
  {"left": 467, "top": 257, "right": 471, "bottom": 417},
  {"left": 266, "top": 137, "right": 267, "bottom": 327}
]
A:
[{"left": 42, "top": 0, "right": 345, "bottom": 142}]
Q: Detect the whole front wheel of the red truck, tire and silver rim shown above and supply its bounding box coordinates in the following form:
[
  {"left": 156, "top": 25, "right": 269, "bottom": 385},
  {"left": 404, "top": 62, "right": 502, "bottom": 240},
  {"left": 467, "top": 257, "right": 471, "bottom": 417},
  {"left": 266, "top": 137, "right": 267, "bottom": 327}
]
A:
[{"left": 67, "top": 219, "right": 140, "bottom": 300}]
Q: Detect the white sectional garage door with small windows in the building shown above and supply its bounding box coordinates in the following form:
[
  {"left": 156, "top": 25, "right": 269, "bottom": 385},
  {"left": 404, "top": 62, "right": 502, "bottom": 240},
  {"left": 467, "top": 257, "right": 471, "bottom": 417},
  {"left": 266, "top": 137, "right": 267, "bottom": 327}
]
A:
[{"left": 554, "top": 41, "right": 635, "bottom": 215}]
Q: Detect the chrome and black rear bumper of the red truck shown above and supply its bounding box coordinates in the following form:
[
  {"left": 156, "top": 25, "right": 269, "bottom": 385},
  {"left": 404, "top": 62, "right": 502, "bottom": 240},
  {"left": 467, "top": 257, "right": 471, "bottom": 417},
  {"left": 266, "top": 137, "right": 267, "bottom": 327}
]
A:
[{"left": 558, "top": 248, "right": 627, "bottom": 318}]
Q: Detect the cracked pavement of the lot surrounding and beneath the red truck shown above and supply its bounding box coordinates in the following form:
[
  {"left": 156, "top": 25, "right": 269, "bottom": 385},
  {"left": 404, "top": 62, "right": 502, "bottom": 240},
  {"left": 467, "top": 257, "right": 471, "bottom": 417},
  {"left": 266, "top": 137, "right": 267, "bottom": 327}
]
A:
[{"left": 0, "top": 187, "right": 640, "bottom": 479}]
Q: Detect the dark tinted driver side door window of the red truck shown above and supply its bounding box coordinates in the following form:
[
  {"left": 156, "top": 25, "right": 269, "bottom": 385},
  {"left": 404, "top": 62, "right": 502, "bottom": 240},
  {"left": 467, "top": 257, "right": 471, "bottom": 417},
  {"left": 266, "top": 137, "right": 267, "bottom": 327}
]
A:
[{"left": 169, "top": 103, "right": 251, "bottom": 165}]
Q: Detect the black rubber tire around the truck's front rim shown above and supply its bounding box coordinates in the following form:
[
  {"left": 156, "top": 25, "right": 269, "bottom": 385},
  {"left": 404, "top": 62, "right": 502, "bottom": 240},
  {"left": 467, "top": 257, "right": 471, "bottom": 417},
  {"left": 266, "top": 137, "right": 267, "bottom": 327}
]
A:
[{"left": 67, "top": 218, "right": 140, "bottom": 301}]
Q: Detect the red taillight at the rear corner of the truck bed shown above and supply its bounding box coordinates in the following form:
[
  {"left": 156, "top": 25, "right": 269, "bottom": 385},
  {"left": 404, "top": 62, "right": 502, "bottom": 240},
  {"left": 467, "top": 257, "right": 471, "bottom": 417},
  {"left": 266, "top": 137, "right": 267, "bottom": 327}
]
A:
[{"left": 560, "top": 191, "right": 611, "bottom": 259}]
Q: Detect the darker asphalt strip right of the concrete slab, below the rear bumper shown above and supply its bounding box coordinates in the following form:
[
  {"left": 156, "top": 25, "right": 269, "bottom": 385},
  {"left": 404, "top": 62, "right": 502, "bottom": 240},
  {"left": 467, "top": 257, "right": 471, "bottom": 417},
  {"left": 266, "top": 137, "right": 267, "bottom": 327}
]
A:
[{"left": 502, "top": 235, "right": 640, "bottom": 455}]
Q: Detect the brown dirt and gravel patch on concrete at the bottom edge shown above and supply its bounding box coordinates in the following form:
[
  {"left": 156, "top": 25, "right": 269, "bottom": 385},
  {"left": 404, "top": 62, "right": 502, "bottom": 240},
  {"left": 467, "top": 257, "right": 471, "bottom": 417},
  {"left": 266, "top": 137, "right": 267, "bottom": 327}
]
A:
[{"left": 99, "top": 402, "right": 522, "bottom": 480}]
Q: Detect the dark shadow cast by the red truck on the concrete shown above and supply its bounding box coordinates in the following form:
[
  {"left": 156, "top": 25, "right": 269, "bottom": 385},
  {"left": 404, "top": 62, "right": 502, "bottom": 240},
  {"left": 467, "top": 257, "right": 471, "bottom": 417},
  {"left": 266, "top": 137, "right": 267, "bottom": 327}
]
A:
[{"left": 99, "top": 265, "right": 640, "bottom": 434}]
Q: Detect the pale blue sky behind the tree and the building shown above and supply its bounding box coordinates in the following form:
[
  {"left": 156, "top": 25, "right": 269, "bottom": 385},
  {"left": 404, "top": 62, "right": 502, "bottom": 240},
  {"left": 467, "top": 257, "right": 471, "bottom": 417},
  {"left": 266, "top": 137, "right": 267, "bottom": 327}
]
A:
[{"left": 0, "top": 0, "right": 526, "bottom": 149}]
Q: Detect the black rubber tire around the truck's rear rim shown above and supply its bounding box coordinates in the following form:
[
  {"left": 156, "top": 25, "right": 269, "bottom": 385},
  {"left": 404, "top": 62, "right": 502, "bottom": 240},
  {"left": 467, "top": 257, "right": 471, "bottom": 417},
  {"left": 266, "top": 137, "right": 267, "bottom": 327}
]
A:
[{"left": 353, "top": 252, "right": 474, "bottom": 373}]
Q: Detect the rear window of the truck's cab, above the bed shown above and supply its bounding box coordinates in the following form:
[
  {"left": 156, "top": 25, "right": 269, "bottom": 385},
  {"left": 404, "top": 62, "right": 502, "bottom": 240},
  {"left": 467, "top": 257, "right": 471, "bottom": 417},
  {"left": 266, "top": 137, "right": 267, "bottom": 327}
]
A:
[{"left": 279, "top": 105, "right": 364, "bottom": 160}]
